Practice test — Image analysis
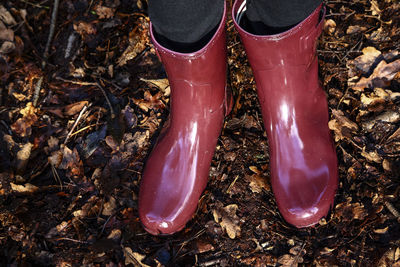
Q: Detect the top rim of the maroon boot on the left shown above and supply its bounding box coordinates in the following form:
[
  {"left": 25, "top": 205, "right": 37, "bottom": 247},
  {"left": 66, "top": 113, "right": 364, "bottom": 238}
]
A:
[{"left": 149, "top": 1, "right": 227, "bottom": 59}]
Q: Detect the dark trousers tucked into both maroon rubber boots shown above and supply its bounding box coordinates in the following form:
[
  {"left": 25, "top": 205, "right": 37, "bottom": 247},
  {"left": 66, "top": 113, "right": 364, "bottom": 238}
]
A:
[{"left": 148, "top": 0, "right": 322, "bottom": 52}]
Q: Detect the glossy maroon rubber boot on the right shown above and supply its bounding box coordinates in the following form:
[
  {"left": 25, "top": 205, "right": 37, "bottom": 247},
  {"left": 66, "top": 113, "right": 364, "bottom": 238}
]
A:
[{"left": 232, "top": 0, "right": 338, "bottom": 228}]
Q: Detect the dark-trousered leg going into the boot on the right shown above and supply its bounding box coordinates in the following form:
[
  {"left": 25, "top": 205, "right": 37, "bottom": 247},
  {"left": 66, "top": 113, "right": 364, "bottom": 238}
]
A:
[{"left": 244, "top": 0, "right": 322, "bottom": 35}]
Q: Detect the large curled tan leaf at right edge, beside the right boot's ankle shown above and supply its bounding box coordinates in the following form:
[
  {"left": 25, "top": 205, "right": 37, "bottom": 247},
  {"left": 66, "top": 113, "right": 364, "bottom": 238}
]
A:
[{"left": 352, "top": 59, "right": 400, "bottom": 91}]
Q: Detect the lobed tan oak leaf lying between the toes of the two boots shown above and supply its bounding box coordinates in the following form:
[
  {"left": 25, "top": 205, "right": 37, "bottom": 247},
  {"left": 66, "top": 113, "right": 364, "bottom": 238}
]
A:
[{"left": 213, "top": 204, "right": 241, "bottom": 239}]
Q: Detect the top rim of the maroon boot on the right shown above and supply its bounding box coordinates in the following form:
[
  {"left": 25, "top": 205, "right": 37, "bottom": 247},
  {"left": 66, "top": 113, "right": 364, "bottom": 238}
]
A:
[{"left": 232, "top": 0, "right": 326, "bottom": 41}]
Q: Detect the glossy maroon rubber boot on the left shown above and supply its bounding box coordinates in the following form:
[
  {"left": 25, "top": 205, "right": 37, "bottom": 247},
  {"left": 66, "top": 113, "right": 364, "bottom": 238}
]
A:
[{"left": 139, "top": 3, "right": 232, "bottom": 235}]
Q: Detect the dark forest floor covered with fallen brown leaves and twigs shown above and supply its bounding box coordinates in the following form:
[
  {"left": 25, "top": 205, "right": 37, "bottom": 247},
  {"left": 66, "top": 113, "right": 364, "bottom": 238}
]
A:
[{"left": 0, "top": 0, "right": 400, "bottom": 267}]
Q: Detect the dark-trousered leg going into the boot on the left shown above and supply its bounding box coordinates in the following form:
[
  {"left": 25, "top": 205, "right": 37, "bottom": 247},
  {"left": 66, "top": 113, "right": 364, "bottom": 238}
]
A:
[{"left": 148, "top": 0, "right": 224, "bottom": 52}]
